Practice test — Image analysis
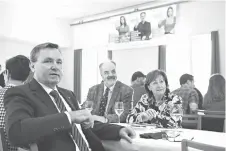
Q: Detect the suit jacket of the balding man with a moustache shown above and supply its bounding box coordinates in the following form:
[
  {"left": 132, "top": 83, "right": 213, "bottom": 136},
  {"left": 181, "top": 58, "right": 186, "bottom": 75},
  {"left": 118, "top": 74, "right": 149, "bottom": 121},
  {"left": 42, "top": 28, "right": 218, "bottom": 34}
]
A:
[{"left": 87, "top": 81, "right": 133, "bottom": 123}]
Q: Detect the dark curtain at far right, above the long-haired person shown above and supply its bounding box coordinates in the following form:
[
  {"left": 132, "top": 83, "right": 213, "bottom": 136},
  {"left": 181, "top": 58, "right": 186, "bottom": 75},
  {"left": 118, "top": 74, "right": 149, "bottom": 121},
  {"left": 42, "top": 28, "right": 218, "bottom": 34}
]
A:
[{"left": 211, "top": 31, "right": 220, "bottom": 74}]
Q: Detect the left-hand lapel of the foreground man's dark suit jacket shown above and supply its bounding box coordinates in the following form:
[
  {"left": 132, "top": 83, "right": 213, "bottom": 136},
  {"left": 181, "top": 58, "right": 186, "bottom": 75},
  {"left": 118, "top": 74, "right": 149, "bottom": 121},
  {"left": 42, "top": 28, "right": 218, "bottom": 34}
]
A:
[{"left": 29, "top": 79, "right": 58, "bottom": 113}]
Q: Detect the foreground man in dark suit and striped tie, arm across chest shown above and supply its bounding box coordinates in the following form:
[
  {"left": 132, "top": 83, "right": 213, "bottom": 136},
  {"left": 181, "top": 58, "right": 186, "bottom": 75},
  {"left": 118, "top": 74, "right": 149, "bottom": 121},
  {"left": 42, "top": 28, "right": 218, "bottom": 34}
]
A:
[{"left": 4, "top": 43, "right": 134, "bottom": 151}]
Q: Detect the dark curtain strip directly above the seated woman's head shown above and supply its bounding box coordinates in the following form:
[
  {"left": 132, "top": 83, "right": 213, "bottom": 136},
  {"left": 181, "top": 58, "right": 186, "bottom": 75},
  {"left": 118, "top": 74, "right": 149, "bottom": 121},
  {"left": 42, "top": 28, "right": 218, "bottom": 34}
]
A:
[{"left": 158, "top": 45, "right": 166, "bottom": 71}]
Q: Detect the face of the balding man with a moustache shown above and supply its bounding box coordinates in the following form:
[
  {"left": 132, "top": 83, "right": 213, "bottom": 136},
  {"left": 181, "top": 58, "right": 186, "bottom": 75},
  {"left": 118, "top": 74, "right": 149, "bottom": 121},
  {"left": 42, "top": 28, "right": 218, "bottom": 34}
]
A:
[{"left": 100, "top": 62, "right": 117, "bottom": 87}]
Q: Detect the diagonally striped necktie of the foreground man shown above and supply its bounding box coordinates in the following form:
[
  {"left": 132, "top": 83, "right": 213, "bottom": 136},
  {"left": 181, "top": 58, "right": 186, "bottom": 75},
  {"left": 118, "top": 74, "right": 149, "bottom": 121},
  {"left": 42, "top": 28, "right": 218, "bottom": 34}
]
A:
[{"left": 49, "top": 90, "right": 89, "bottom": 151}]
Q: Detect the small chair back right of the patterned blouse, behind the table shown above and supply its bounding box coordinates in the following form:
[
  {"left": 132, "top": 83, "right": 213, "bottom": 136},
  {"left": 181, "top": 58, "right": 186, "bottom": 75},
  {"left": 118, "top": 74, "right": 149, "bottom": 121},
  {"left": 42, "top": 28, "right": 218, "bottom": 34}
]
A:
[{"left": 182, "top": 114, "right": 200, "bottom": 129}]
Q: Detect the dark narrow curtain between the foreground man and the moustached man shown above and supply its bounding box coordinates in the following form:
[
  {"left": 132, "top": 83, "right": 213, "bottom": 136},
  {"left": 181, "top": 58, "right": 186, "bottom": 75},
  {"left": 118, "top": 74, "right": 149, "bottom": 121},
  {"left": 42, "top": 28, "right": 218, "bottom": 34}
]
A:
[{"left": 74, "top": 49, "right": 82, "bottom": 103}]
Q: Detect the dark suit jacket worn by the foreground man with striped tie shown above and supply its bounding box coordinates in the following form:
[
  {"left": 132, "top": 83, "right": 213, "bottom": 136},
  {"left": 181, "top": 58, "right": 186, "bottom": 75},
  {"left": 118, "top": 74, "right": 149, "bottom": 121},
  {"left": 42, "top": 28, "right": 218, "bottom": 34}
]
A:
[{"left": 4, "top": 79, "right": 121, "bottom": 151}]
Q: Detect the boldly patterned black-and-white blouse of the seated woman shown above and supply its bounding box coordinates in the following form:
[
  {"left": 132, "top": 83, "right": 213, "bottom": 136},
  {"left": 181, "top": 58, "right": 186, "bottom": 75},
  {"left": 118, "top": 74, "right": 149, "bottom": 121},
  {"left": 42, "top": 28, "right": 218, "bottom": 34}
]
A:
[{"left": 127, "top": 93, "right": 182, "bottom": 128}]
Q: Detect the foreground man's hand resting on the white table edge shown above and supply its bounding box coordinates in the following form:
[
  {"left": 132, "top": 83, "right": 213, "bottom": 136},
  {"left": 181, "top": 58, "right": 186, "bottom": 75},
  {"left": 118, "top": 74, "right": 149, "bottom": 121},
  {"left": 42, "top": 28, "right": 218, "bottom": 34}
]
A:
[{"left": 119, "top": 127, "right": 136, "bottom": 143}]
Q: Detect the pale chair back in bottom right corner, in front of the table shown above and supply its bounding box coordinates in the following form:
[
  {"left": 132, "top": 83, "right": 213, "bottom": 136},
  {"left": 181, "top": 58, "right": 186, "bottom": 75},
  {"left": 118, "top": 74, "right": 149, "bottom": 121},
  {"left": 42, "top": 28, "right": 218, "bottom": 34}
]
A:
[{"left": 181, "top": 139, "right": 225, "bottom": 151}]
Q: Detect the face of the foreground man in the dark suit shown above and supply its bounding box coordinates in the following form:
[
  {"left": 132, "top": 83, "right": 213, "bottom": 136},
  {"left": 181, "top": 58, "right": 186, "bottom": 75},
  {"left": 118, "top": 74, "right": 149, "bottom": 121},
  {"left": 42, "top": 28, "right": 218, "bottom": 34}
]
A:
[{"left": 32, "top": 48, "right": 63, "bottom": 88}]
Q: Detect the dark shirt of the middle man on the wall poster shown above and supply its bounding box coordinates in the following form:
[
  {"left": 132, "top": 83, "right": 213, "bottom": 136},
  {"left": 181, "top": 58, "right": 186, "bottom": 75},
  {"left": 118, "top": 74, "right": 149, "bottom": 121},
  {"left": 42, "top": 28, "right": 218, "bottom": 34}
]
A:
[{"left": 134, "top": 21, "right": 151, "bottom": 40}]
